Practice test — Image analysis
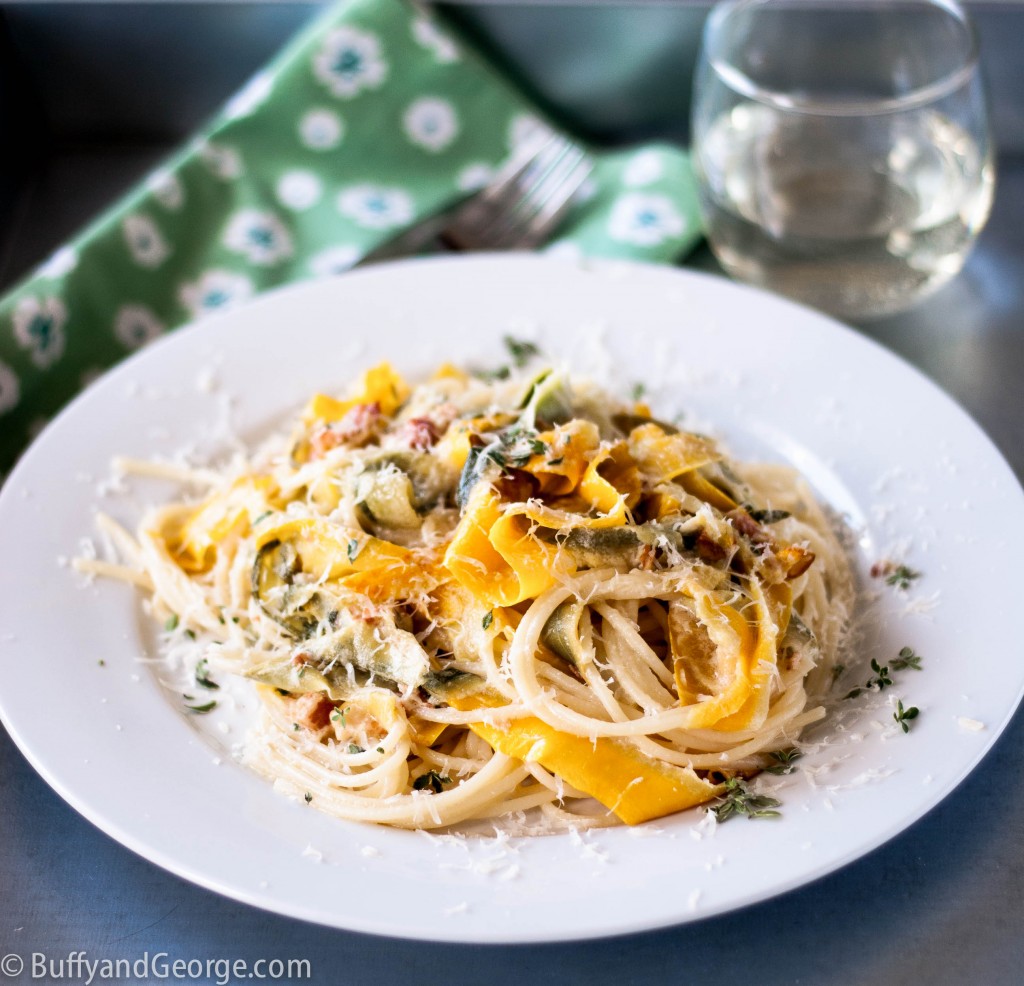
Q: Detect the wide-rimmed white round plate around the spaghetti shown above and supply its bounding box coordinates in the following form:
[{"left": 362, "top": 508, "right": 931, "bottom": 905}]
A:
[{"left": 0, "top": 257, "right": 1024, "bottom": 942}]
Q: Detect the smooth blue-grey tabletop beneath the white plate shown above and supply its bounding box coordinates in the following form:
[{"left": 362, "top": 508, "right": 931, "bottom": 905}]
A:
[{"left": 0, "top": 3, "right": 1024, "bottom": 986}]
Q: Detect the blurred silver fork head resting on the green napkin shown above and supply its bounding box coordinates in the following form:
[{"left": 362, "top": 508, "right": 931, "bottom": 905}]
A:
[{"left": 438, "top": 128, "right": 594, "bottom": 251}]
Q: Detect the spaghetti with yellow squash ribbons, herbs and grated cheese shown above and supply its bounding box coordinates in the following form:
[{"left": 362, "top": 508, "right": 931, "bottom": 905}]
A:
[{"left": 80, "top": 363, "right": 852, "bottom": 828}]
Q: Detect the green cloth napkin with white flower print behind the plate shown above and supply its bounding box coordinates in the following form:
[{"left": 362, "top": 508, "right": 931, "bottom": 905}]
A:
[{"left": 0, "top": 0, "right": 700, "bottom": 475}]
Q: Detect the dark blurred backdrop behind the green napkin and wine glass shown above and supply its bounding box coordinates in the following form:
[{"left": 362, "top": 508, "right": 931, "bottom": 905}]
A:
[{"left": 0, "top": 0, "right": 1024, "bottom": 289}]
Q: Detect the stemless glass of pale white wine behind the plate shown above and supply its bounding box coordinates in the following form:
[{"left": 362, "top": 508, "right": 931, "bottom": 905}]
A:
[{"left": 692, "top": 0, "right": 994, "bottom": 319}]
